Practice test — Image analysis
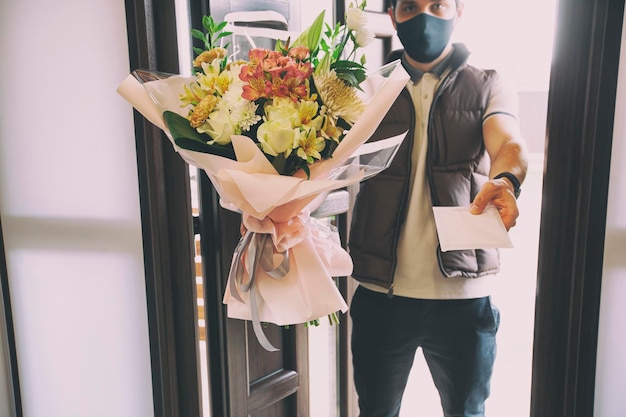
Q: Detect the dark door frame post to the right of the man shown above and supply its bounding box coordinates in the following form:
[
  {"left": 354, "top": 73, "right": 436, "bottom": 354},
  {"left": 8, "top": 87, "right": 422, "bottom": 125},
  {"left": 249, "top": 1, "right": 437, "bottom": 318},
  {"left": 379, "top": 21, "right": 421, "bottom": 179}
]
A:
[{"left": 531, "top": 0, "right": 626, "bottom": 417}]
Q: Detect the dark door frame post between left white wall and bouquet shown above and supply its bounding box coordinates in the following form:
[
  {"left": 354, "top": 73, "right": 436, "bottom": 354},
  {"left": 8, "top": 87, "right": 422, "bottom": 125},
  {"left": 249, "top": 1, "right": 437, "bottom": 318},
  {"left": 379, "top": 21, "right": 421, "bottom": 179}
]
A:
[{"left": 120, "top": 0, "right": 202, "bottom": 417}]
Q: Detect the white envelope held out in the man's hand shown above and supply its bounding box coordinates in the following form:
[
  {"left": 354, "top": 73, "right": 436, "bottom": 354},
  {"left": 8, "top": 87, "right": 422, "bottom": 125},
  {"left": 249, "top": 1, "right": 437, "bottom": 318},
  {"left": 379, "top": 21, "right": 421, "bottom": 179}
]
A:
[{"left": 433, "top": 206, "right": 513, "bottom": 252}]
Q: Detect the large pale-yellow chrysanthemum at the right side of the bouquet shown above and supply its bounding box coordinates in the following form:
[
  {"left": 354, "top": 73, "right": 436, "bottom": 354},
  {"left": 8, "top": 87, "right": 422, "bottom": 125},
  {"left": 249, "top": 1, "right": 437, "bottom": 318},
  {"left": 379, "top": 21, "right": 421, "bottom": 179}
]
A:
[{"left": 314, "top": 71, "right": 365, "bottom": 124}]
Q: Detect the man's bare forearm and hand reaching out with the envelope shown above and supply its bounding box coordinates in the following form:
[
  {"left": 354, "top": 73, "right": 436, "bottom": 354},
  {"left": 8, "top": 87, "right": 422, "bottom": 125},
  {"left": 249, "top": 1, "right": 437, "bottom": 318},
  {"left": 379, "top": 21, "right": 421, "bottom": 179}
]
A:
[{"left": 471, "top": 114, "right": 528, "bottom": 230}]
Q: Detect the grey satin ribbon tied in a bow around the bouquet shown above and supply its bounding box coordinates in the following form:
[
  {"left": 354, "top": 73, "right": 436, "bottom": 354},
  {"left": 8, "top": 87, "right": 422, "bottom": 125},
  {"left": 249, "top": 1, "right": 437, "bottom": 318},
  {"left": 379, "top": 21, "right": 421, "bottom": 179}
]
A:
[{"left": 228, "top": 230, "right": 289, "bottom": 352}]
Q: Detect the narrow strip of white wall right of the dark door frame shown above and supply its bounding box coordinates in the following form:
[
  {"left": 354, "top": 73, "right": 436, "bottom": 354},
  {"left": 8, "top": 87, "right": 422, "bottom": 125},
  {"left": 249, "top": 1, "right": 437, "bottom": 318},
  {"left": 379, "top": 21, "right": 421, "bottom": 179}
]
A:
[{"left": 594, "top": 9, "right": 626, "bottom": 417}]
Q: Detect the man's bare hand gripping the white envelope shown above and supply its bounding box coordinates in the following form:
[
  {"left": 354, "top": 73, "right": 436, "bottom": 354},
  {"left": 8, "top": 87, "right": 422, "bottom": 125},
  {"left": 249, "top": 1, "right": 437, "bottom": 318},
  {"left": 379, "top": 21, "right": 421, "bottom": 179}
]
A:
[{"left": 470, "top": 178, "right": 519, "bottom": 230}]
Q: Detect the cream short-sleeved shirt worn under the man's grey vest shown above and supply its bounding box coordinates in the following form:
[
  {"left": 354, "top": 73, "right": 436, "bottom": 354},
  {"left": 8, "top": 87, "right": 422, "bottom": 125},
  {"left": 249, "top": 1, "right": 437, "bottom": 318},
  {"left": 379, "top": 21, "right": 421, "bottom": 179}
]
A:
[{"left": 361, "top": 66, "right": 518, "bottom": 299}]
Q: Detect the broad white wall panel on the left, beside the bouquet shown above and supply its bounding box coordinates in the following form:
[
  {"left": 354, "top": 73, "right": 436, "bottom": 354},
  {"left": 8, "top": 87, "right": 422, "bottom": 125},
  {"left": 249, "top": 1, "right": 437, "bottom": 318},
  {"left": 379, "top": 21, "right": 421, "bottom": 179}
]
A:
[{"left": 0, "top": 0, "right": 153, "bottom": 417}]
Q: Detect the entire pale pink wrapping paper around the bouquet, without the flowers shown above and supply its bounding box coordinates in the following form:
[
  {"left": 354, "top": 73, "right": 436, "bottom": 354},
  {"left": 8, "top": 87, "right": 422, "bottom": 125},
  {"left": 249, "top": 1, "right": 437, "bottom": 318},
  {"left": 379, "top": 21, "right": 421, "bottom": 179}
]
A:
[{"left": 118, "top": 62, "right": 409, "bottom": 336}]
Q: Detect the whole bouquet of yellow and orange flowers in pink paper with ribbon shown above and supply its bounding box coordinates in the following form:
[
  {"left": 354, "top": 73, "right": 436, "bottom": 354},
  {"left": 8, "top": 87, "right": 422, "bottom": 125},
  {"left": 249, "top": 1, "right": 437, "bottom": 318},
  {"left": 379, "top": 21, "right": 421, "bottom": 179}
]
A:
[{"left": 118, "top": 2, "right": 408, "bottom": 350}]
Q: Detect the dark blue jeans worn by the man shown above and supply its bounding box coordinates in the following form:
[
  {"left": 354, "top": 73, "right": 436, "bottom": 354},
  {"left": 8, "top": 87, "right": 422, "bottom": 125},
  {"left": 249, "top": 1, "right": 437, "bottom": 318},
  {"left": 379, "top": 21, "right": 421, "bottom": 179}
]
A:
[{"left": 350, "top": 286, "right": 500, "bottom": 417}]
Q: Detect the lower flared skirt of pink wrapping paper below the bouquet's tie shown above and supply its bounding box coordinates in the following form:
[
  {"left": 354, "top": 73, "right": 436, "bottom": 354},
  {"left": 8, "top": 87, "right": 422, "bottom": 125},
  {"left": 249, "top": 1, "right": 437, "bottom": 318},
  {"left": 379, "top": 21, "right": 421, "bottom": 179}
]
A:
[{"left": 224, "top": 213, "right": 352, "bottom": 325}]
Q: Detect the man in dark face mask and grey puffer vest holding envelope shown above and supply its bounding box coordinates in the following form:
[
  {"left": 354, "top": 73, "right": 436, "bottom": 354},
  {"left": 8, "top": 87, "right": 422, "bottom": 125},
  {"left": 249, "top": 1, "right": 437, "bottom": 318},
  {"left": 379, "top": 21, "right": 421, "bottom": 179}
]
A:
[{"left": 350, "top": 0, "right": 527, "bottom": 417}]
